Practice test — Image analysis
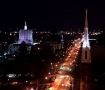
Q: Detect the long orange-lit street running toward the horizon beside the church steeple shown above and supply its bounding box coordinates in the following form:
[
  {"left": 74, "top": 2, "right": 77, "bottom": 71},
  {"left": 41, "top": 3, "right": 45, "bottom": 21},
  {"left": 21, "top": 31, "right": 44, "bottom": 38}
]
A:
[{"left": 48, "top": 39, "right": 81, "bottom": 90}]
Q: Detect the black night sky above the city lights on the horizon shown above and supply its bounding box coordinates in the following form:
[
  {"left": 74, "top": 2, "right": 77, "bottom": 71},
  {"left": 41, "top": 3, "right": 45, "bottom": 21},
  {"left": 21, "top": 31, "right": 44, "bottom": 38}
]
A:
[{"left": 0, "top": 0, "right": 105, "bottom": 30}]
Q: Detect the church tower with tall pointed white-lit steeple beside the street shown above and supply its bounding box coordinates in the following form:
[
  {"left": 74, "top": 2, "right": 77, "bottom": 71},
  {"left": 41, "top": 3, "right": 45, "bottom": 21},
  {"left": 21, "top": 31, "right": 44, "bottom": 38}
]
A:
[{"left": 80, "top": 9, "right": 91, "bottom": 90}]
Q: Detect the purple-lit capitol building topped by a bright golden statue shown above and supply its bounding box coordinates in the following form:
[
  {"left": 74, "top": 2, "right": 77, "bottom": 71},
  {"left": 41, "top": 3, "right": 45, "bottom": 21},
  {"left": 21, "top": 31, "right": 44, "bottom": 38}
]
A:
[{"left": 8, "top": 22, "right": 39, "bottom": 54}]
